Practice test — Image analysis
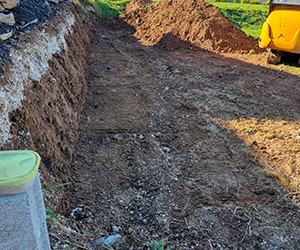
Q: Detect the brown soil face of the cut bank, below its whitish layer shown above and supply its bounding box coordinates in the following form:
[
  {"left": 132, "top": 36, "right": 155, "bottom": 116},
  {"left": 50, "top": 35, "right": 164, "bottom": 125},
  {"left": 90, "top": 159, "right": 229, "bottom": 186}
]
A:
[{"left": 1, "top": 1, "right": 92, "bottom": 213}]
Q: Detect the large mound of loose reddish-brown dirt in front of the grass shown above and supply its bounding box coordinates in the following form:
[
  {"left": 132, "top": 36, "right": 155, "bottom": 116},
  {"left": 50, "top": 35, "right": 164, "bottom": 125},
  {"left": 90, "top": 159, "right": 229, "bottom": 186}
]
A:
[{"left": 121, "top": 0, "right": 260, "bottom": 53}]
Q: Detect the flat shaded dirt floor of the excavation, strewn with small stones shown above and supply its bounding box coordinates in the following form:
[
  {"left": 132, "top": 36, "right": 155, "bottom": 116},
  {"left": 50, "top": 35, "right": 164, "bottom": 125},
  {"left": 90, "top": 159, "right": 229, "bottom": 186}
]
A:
[{"left": 56, "top": 4, "right": 300, "bottom": 249}]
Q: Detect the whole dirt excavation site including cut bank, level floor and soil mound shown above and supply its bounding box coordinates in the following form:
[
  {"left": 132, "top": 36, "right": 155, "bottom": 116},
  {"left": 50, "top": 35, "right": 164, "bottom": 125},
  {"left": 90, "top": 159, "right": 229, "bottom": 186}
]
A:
[{"left": 0, "top": 0, "right": 300, "bottom": 250}]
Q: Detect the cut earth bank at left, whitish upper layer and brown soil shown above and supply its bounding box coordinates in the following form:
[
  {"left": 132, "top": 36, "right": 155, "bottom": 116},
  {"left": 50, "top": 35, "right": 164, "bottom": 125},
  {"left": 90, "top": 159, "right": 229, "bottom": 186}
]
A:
[{"left": 0, "top": 6, "right": 91, "bottom": 212}]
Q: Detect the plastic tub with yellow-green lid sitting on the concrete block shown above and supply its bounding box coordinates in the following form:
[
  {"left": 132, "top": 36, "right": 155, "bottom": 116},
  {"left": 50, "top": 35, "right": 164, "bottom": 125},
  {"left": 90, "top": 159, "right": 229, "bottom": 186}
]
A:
[{"left": 0, "top": 150, "right": 41, "bottom": 196}]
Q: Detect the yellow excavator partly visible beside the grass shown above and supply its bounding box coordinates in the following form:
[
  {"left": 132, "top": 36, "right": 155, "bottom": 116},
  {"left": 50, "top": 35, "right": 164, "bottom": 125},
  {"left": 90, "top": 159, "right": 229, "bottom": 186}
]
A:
[{"left": 259, "top": 0, "right": 300, "bottom": 65}]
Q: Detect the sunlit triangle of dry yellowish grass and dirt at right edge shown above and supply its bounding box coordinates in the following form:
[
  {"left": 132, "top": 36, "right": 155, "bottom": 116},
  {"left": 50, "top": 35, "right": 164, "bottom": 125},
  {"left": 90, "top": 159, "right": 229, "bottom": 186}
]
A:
[{"left": 220, "top": 118, "right": 300, "bottom": 198}]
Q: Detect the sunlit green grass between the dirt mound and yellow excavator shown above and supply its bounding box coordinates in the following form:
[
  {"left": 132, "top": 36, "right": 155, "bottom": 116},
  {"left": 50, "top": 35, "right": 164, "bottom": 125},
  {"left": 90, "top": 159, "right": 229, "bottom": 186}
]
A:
[{"left": 210, "top": 0, "right": 269, "bottom": 37}]
